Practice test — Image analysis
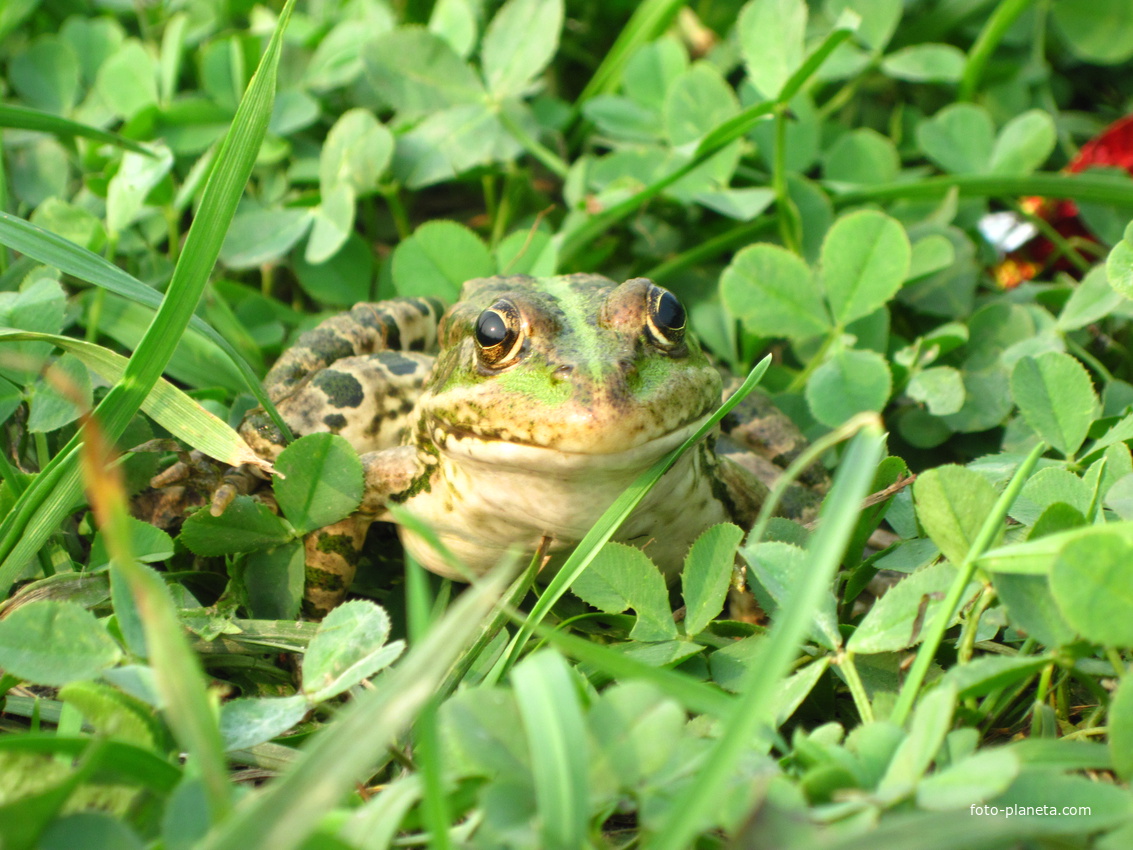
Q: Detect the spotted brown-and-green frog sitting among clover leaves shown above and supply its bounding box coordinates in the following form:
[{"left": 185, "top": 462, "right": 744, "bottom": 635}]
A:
[{"left": 157, "top": 273, "right": 804, "bottom": 615}]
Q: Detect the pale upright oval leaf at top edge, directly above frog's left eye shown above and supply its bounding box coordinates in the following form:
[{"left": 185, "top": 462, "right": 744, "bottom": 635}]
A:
[{"left": 480, "top": 0, "right": 563, "bottom": 99}]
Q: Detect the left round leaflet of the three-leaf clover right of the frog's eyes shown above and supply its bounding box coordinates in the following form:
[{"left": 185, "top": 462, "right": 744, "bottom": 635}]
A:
[{"left": 719, "top": 244, "right": 830, "bottom": 339}]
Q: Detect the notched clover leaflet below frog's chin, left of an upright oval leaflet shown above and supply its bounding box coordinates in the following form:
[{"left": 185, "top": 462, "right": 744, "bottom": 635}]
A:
[{"left": 571, "top": 543, "right": 678, "bottom": 640}]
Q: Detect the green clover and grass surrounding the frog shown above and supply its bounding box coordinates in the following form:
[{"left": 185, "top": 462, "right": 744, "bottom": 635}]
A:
[{"left": 0, "top": 0, "right": 1133, "bottom": 850}]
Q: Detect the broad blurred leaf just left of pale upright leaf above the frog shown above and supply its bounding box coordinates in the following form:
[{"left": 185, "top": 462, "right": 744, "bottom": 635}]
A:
[{"left": 364, "top": 27, "right": 485, "bottom": 118}]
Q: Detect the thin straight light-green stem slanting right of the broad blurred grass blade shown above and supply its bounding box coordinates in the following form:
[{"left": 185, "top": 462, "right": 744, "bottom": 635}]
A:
[{"left": 889, "top": 443, "right": 1047, "bottom": 725}]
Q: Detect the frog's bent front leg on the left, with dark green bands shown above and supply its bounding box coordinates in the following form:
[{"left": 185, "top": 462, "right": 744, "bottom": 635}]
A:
[{"left": 303, "top": 445, "right": 427, "bottom": 618}]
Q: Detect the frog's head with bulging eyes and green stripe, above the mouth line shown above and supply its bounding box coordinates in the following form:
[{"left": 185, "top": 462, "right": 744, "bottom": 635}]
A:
[{"left": 420, "top": 274, "right": 721, "bottom": 456}]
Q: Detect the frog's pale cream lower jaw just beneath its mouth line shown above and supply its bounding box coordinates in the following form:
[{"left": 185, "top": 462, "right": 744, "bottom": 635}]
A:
[{"left": 434, "top": 413, "right": 712, "bottom": 474}]
